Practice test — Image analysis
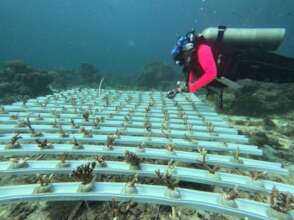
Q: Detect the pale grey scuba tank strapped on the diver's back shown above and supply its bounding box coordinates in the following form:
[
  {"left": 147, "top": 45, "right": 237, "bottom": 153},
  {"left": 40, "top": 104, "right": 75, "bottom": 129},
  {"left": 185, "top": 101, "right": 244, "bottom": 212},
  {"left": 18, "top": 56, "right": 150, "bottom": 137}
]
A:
[{"left": 200, "top": 26, "right": 286, "bottom": 51}]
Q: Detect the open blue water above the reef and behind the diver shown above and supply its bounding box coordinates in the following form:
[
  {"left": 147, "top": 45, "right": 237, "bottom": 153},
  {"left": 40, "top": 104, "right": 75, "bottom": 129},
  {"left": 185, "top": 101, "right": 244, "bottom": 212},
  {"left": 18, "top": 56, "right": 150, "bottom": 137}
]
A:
[{"left": 0, "top": 0, "right": 294, "bottom": 73}]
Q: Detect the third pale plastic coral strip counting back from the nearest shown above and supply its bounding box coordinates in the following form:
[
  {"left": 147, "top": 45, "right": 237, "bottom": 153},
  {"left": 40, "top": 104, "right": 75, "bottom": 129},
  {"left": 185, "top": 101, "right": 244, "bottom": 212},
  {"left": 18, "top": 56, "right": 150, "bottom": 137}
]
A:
[{"left": 0, "top": 144, "right": 289, "bottom": 175}]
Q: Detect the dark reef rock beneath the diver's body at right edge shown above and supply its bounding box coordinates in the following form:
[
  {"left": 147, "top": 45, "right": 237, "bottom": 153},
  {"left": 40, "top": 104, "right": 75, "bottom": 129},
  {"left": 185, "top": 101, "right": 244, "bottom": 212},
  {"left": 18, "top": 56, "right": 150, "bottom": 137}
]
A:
[{"left": 226, "top": 79, "right": 294, "bottom": 116}]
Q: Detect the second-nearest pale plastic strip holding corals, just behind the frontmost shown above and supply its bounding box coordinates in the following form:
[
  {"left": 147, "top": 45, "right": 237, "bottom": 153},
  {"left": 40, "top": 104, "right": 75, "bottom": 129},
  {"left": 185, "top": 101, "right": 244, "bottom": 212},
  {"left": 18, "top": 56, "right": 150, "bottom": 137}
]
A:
[{"left": 0, "top": 160, "right": 294, "bottom": 194}]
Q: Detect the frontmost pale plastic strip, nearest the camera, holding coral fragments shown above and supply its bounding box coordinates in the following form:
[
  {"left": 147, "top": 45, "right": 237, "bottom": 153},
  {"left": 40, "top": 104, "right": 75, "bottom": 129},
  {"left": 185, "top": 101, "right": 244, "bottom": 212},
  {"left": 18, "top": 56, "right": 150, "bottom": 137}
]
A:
[{"left": 0, "top": 182, "right": 278, "bottom": 220}]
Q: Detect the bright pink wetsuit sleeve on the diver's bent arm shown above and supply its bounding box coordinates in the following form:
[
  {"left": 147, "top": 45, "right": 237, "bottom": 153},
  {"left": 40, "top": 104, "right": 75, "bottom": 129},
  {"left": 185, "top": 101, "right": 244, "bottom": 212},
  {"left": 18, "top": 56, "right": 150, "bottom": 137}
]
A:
[{"left": 188, "top": 44, "right": 217, "bottom": 93}]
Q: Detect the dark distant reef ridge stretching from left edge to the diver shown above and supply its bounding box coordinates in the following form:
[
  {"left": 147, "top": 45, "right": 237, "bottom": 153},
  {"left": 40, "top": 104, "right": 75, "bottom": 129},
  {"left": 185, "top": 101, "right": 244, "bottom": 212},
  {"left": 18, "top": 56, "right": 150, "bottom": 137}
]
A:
[{"left": 0, "top": 60, "right": 180, "bottom": 104}]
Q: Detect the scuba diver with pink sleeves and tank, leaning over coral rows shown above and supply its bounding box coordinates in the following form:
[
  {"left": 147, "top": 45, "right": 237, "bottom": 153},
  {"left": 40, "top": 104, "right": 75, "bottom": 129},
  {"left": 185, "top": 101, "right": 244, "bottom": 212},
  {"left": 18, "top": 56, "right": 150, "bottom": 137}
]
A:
[{"left": 167, "top": 26, "right": 294, "bottom": 99}]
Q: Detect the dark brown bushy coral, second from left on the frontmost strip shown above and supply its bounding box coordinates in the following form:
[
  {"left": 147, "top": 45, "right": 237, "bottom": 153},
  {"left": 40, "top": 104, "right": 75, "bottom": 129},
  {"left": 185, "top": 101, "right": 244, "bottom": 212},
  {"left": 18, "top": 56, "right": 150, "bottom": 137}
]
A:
[{"left": 71, "top": 162, "right": 96, "bottom": 185}]
